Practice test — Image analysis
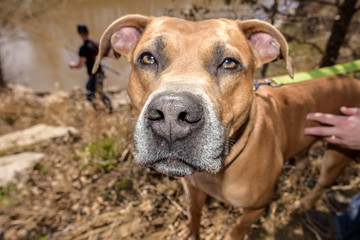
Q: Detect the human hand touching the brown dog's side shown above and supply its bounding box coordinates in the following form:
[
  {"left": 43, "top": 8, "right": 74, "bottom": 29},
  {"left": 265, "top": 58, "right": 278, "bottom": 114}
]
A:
[{"left": 305, "top": 107, "right": 360, "bottom": 150}]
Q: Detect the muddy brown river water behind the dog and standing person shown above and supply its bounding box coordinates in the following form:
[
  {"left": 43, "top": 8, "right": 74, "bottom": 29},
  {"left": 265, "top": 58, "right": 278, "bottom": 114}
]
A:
[{"left": 1, "top": 0, "right": 286, "bottom": 92}]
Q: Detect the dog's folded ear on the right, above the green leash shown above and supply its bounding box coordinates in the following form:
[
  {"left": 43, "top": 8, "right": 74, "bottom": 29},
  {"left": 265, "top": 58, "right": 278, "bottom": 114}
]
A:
[{"left": 239, "top": 20, "right": 294, "bottom": 78}]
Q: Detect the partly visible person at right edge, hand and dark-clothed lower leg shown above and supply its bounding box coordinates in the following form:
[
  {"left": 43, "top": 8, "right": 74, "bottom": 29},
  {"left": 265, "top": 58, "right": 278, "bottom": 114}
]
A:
[{"left": 305, "top": 107, "right": 360, "bottom": 240}]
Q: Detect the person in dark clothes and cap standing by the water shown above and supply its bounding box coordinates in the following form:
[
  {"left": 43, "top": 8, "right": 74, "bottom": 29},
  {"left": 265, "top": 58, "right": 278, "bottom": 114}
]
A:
[{"left": 69, "top": 24, "right": 112, "bottom": 113}]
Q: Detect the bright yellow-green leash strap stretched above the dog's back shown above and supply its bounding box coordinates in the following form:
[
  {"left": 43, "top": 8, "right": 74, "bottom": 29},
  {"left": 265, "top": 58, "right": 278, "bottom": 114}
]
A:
[{"left": 271, "top": 59, "right": 360, "bottom": 85}]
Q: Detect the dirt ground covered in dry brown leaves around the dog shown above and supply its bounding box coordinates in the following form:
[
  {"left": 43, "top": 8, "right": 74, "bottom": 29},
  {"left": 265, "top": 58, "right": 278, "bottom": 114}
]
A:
[{"left": 0, "top": 86, "right": 359, "bottom": 240}]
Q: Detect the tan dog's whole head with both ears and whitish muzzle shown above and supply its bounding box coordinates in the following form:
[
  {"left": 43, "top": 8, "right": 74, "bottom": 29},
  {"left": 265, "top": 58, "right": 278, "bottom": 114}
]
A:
[{"left": 94, "top": 15, "right": 291, "bottom": 176}]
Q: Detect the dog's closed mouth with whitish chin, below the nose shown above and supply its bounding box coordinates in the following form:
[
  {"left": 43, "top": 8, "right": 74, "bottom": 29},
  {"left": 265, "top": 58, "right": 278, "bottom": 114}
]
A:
[{"left": 149, "top": 156, "right": 199, "bottom": 177}]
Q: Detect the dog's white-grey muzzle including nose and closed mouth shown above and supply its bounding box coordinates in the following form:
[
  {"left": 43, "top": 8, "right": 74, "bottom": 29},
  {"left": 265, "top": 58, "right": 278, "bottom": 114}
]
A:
[{"left": 135, "top": 92, "right": 227, "bottom": 176}]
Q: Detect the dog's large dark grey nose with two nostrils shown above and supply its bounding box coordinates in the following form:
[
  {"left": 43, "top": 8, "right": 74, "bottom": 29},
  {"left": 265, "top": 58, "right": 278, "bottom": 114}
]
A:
[{"left": 145, "top": 93, "right": 204, "bottom": 143}]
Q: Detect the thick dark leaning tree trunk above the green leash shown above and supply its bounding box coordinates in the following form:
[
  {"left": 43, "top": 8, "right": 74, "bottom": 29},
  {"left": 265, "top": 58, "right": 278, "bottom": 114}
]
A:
[{"left": 320, "top": 0, "right": 357, "bottom": 67}]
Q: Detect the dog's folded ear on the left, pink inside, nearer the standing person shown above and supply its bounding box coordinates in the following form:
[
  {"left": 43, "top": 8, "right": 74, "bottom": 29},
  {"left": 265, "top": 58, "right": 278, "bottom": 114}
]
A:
[{"left": 92, "top": 14, "right": 152, "bottom": 73}]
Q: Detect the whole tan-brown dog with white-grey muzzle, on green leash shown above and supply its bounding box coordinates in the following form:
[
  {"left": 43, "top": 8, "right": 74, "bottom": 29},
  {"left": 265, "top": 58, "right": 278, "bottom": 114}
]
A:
[{"left": 95, "top": 15, "right": 360, "bottom": 239}]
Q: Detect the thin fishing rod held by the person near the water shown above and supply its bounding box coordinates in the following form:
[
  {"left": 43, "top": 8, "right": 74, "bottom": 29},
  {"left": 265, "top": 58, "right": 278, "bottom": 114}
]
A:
[{"left": 0, "top": 13, "right": 121, "bottom": 76}]
